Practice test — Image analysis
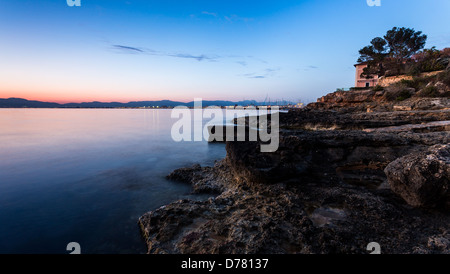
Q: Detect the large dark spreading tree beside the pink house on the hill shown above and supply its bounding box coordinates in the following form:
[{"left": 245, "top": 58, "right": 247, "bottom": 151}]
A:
[{"left": 358, "top": 27, "right": 427, "bottom": 78}]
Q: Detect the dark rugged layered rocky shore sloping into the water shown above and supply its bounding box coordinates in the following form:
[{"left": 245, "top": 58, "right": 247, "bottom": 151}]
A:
[{"left": 139, "top": 72, "right": 450, "bottom": 254}]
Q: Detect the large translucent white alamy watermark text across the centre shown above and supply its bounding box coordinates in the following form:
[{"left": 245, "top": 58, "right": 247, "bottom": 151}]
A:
[{"left": 171, "top": 99, "right": 280, "bottom": 152}]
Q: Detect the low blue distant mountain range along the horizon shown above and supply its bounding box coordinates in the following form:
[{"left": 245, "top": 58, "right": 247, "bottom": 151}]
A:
[{"left": 0, "top": 98, "right": 270, "bottom": 108}]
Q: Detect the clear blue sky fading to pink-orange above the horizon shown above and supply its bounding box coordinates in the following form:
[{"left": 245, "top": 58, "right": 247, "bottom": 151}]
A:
[{"left": 0, "top": 0, "right": 450, "bottom": 103}]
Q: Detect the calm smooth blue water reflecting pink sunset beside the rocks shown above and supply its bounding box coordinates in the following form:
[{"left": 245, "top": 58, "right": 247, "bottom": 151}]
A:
[{"left": 0, "top": 109, "right": 225, "bottom": 253}]
